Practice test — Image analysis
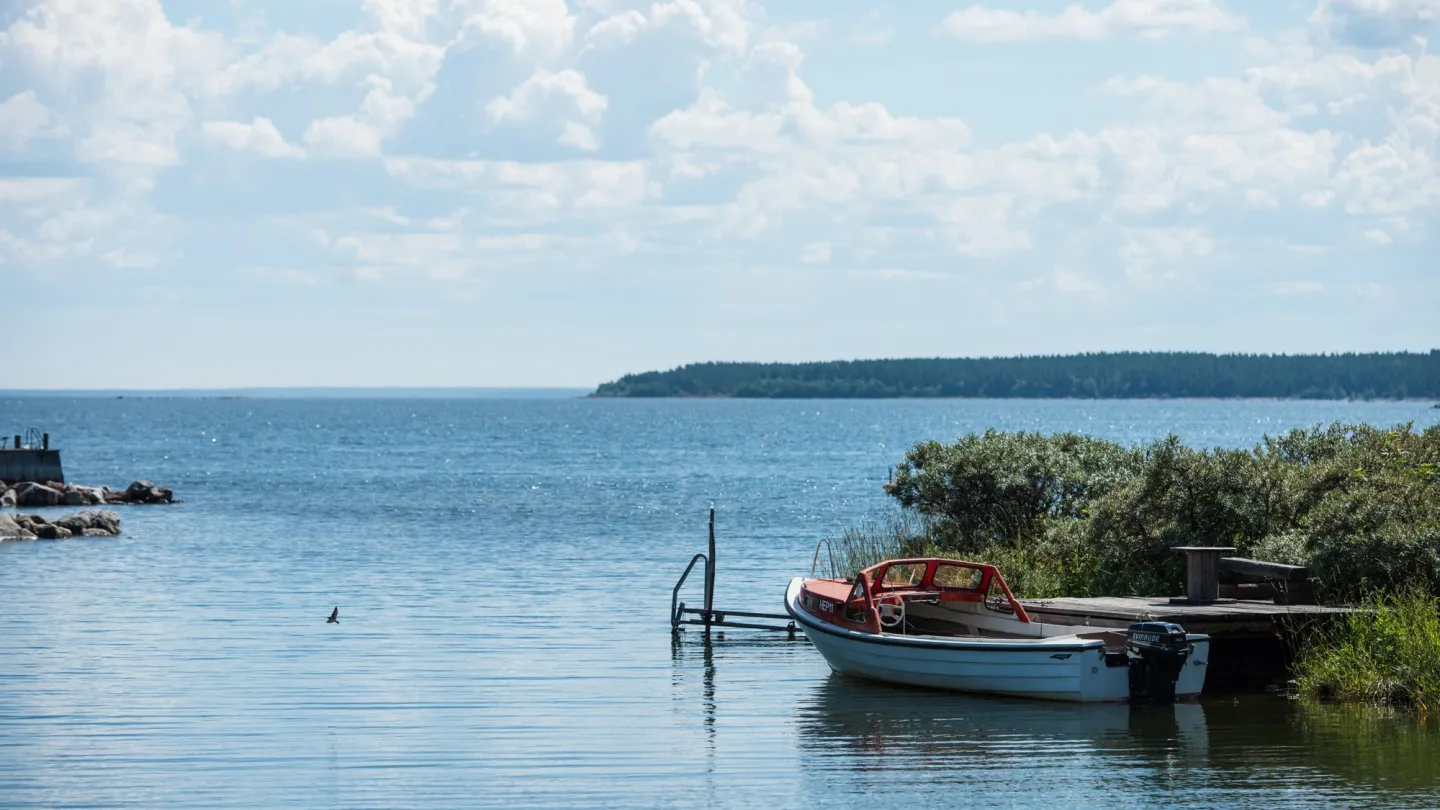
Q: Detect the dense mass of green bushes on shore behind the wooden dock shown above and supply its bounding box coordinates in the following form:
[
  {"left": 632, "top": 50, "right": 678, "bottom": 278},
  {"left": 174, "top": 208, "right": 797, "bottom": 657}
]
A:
[{"left": 837, "top": 424, "right": 1440, "bottom": 600}]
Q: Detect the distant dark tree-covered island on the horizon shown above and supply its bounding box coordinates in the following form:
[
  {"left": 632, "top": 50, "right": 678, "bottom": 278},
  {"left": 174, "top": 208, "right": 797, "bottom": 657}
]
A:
[{"left": 590, "top": 349, "right": 1440, "bottom": 399}]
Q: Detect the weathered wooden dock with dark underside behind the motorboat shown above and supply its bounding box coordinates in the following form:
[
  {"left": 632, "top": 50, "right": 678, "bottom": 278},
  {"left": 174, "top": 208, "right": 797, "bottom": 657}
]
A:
[{"left": 1021, "top": 597, "right": 1354, "bottom": 693}]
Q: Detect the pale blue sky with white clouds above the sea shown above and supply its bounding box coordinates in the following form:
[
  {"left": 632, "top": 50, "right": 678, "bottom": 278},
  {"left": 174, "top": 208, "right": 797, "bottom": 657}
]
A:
[{"left": 0, "top": 0, "right": 1440, "bottom": 388}]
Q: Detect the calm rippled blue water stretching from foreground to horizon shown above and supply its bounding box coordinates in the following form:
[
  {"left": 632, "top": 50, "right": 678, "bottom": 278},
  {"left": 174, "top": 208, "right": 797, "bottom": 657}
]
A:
[{"left": 0, "top": 393, "right": 1440, "bottom": 807}]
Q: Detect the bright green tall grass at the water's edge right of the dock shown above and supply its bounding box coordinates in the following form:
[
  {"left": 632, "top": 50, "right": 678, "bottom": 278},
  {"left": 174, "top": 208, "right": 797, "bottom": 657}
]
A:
[{"left": 1295, "top": 587, "right": 1440, "bottom": 715}]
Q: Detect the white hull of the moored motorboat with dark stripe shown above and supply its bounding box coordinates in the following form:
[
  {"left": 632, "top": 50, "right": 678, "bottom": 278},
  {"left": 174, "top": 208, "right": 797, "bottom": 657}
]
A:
[{"left": 785, "top": 578, "right": 1210, "bottom": 703}]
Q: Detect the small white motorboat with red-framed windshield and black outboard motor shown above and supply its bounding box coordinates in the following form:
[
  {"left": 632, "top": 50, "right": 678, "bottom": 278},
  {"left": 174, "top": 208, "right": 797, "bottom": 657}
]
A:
[{"left": 785, "top": 558, "right": 1210, "bottom": 703}]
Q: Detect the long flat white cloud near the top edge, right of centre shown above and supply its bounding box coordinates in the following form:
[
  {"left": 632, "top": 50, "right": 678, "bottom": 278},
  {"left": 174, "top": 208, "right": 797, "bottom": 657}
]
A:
[{"left": 942, "top": 0, "right": 1244, "bottom": 42}]
